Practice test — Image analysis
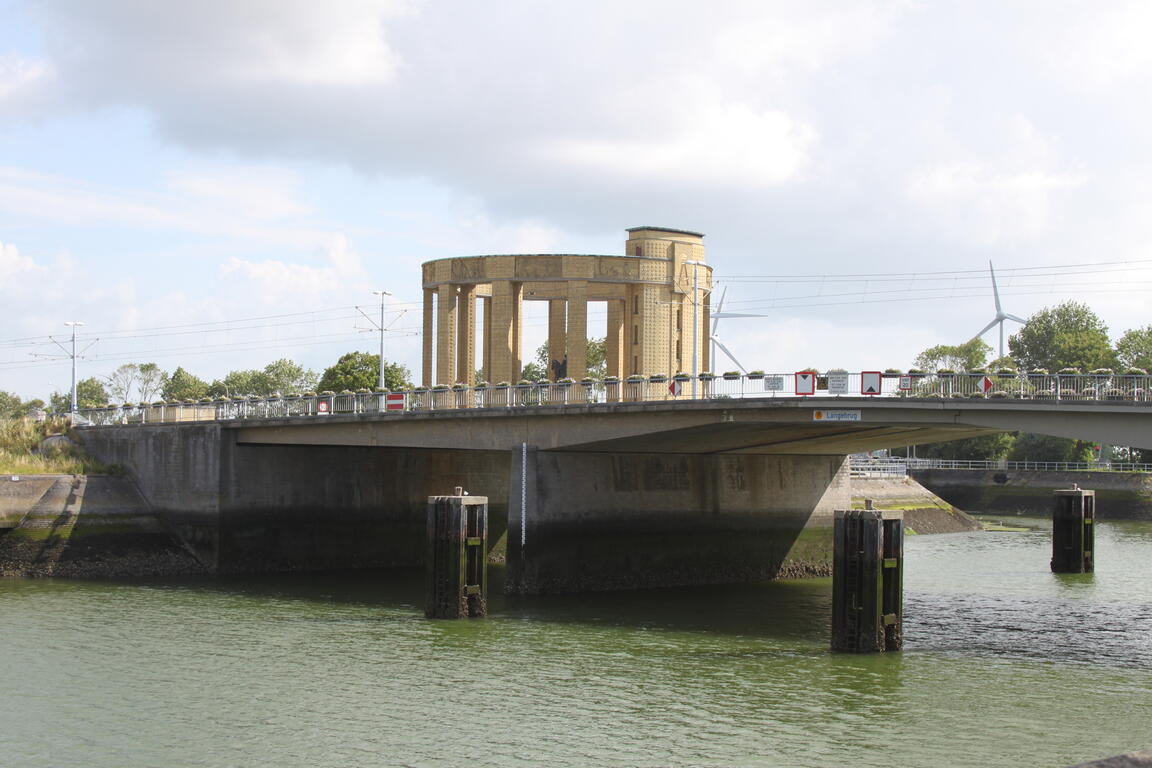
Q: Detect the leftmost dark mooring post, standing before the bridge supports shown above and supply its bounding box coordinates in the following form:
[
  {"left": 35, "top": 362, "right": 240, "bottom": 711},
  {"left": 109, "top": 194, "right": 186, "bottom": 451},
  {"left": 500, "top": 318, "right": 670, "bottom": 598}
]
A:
[{"left": 424, "top": 487, "right": 488, "bottom": 618}]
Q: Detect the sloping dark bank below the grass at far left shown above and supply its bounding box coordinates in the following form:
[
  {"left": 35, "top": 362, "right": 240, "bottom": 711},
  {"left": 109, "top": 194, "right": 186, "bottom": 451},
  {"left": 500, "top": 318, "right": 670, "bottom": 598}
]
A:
[{"left": 0, "top": 474, "right": 207, "bottom": 578}]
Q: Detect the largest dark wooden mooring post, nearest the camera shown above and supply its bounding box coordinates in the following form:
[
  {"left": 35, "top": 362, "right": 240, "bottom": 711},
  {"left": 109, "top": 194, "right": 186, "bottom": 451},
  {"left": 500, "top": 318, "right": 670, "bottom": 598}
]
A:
[{"left": 832, "top": 504, "right": 904, "bottom": 653}]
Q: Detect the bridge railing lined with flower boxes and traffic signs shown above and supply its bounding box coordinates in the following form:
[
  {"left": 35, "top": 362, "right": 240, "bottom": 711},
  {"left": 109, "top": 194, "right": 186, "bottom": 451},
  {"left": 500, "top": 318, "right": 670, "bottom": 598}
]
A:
[{"left": 76, "top": 372, "right": 1152, "bottom": 426}]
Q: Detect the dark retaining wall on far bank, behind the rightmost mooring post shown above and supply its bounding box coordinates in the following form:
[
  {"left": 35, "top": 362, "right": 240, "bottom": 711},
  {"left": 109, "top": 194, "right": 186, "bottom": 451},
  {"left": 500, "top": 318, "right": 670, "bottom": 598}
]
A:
[{"left": 910, "top": 470, "right": 1152, "bottom": 520}]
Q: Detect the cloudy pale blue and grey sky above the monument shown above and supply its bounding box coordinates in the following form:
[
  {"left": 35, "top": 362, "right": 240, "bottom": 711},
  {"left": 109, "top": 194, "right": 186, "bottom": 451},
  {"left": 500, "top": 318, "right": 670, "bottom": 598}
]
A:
[{"left": 0, "top": 0, "right": 1152, "bottom": 398}]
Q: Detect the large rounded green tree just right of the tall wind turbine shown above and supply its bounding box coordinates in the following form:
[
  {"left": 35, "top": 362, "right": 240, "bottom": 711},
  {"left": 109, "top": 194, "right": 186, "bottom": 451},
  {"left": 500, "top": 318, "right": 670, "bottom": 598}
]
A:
[{"left": 1008, "top": 302, "right": 1116, "bottom": 371}]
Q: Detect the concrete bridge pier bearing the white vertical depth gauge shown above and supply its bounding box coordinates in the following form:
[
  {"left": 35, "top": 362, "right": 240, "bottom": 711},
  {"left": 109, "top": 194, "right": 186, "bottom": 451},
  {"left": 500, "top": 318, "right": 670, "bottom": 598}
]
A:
[{"left": 506, "top": 446, "right": 850, "bottom": 593}]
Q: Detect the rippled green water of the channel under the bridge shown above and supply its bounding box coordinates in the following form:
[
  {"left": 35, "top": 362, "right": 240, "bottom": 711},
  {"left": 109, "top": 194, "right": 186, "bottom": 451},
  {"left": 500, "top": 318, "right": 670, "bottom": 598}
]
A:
[{"left": 0, "top": 518, "right": 1152, "bottom": 768}]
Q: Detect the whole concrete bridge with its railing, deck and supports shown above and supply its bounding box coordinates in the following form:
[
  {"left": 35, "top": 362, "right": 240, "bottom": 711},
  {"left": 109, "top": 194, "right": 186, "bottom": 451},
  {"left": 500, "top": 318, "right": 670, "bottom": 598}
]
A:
[{"left": 77, "top": 374, "right": 1152, "bottom": 592}]
